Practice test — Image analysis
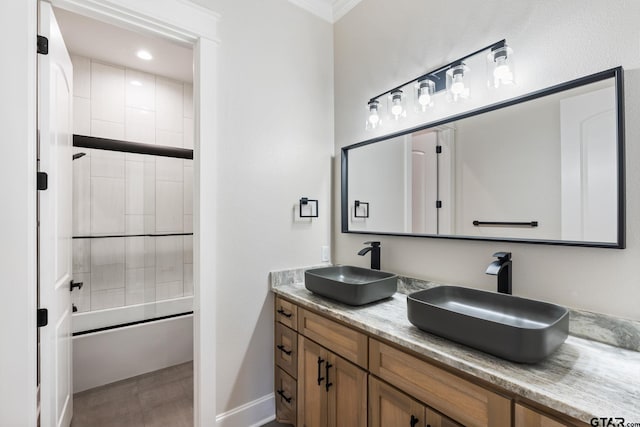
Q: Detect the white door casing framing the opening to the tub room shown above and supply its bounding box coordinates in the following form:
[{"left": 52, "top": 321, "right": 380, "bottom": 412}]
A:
[{"left": 0, "top": 0, "right": 220, "bottom": 426}]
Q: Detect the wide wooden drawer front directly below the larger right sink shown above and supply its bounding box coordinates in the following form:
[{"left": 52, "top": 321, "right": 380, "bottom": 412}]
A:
[{"left": 369, "top": 339, "right": 511, "bottom": 427}]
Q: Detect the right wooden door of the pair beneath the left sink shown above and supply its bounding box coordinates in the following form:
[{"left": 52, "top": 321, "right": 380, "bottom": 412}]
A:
[{"left": 325, "top": 352, "right": 367, "bottom": 427}]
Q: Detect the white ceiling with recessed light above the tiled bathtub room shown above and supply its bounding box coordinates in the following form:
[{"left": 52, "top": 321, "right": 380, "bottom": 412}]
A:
[{"left": 55, "top": 9, "right": 193, "bottom": 82}]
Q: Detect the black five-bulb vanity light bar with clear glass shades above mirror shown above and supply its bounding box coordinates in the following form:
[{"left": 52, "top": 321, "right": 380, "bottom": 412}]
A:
[{"left": 366, "top": 39, "right": 514, "bottom": 130}]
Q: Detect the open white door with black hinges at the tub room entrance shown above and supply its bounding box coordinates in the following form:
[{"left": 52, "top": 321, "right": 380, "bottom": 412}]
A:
[{"left": 38, "top": 2, "right": 73, "bottom": 427}]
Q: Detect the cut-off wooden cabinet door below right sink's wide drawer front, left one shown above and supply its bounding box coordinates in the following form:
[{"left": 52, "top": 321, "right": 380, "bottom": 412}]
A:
[{"left": 369, "top": 377, "right": 424, "bottom": 427}]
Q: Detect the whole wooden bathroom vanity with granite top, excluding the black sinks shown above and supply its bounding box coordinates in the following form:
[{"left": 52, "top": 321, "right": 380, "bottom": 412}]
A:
[{"left": 271, "top": 272, "right": 640, "bottom": 427}]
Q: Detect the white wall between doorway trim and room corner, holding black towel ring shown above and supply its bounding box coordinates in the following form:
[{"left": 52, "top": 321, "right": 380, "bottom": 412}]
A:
[{"left": 189, "top": 0, "right": 333, "bottom": 425}]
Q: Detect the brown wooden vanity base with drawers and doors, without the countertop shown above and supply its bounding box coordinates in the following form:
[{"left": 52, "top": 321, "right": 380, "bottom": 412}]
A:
[{"left": 274, "top": 297, "right": 587, "bottom": 427}]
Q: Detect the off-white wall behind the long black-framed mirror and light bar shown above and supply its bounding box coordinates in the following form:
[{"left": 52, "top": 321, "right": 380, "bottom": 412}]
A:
[{"left": 333, "top": 0, "right": 640, "bottom": 319}]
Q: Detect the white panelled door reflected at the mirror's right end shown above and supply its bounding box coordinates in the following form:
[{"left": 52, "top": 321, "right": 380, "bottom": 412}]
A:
[{"left": 560, "top": 86, "right": 618, "bottom": 242}]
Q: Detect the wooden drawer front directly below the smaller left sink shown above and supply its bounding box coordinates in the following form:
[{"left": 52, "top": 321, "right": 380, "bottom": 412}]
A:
[{"left": 298, "top": 308, "right": 368, "bottom": 369}]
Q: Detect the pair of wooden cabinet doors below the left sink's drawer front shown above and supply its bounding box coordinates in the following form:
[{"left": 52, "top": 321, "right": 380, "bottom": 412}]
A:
[{"left": 298, "top": 335, "right": 367, "bottom": 427}]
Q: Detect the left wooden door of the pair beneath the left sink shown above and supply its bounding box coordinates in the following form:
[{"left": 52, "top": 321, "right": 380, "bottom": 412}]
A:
[{"left": 298, "top": 335, "right": 327, "bottom": 427}]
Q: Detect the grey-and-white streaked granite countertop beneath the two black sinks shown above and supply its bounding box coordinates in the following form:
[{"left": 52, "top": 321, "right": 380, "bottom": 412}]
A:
[{"left": 272, "top": 270, "right": 640, "bottom": 423}]
